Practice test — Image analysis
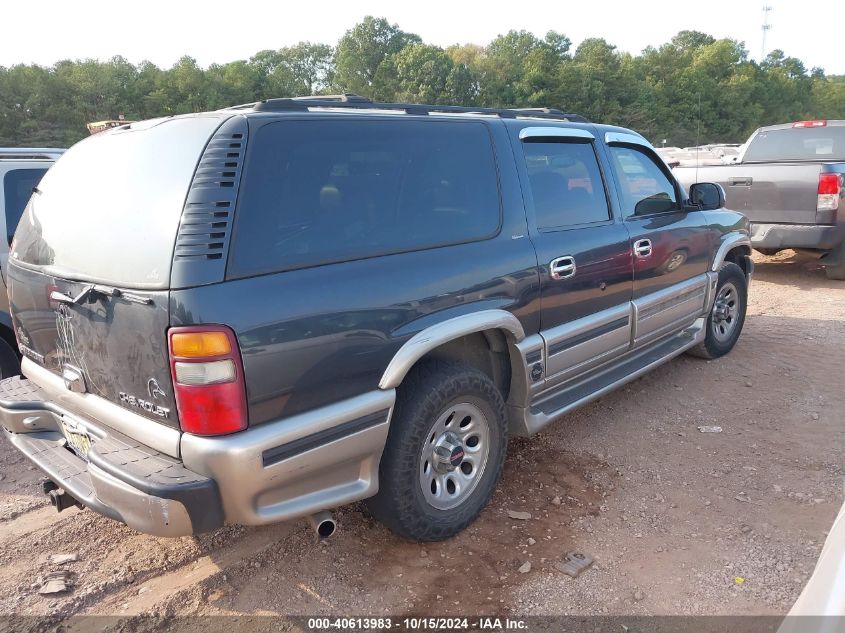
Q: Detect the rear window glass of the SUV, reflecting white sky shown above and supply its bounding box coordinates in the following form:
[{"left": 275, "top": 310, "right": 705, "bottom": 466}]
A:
[{"left": 11, "top": 115, "right": 221, "bottom": 289}]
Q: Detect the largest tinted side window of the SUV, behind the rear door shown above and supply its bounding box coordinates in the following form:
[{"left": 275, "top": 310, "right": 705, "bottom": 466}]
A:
[{"left": 228, "top": 119, "right": 500, "bottom": 277}]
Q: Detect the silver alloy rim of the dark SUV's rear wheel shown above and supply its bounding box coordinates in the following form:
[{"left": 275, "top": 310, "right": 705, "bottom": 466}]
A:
[{"left": 419, "top": 402, "right": 490, "bottom": 510}]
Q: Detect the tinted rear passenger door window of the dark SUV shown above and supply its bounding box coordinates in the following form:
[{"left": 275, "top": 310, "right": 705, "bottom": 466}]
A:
[{"left": 522, "top": 141, "right": 610, "bottom": 229}]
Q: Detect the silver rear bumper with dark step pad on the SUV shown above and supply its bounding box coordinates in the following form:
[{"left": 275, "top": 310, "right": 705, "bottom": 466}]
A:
[{"left": 0, "top": 376, "right": 223, "bottom": 536}]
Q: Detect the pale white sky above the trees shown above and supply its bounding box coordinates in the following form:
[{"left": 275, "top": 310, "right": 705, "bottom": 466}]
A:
[{"left": 0, "top": 0, "right": 845, "bottom": 74}]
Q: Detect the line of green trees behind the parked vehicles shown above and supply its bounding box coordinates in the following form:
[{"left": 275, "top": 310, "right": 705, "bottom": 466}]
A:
[{"left": 0, "top": 17, "right": 845, "bottom": 146}]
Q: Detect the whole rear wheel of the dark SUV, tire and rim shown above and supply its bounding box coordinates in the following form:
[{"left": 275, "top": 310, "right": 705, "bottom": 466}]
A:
[{"left": 365, "top": 360, "right": 507, "bottom": 541}]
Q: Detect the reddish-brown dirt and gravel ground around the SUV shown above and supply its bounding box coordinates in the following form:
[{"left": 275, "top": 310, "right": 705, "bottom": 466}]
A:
[{"left": 0, "top": 252, "right": 845, "bottom": 616}]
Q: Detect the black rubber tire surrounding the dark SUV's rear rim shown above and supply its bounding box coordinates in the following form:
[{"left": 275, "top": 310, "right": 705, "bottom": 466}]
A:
[{"left": 365, "top": 360, "right": 507, "bottom": 541}]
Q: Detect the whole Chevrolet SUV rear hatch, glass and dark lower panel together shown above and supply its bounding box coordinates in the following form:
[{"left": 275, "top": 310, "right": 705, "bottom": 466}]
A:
[{"left": 9, "top": 115, "right": 225, "bottom": 427}]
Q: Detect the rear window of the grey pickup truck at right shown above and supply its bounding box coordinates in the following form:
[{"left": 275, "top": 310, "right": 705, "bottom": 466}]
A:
[{"left": 743, "top": 125, "right": 845, "bottom": 162}]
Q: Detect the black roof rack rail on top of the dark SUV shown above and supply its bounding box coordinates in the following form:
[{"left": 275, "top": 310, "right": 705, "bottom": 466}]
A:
[{"left": 230, "top": 93, "right": 589, "bottom": 123}]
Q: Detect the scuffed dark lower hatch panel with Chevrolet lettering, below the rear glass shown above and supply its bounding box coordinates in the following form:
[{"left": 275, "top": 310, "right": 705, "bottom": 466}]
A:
[{"left": 9, "top": 266, "right": 178, "bottom": 427}]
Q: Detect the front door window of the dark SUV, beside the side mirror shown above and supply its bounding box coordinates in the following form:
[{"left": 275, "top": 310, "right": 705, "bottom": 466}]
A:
[{"left": 610, "top": 145, "right": 678, "bottom": 215}]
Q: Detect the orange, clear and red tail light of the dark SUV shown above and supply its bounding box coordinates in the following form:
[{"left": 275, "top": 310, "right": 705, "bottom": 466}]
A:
[{"left": 168, "top": 325, "right": 247, "bottom": 435}]
